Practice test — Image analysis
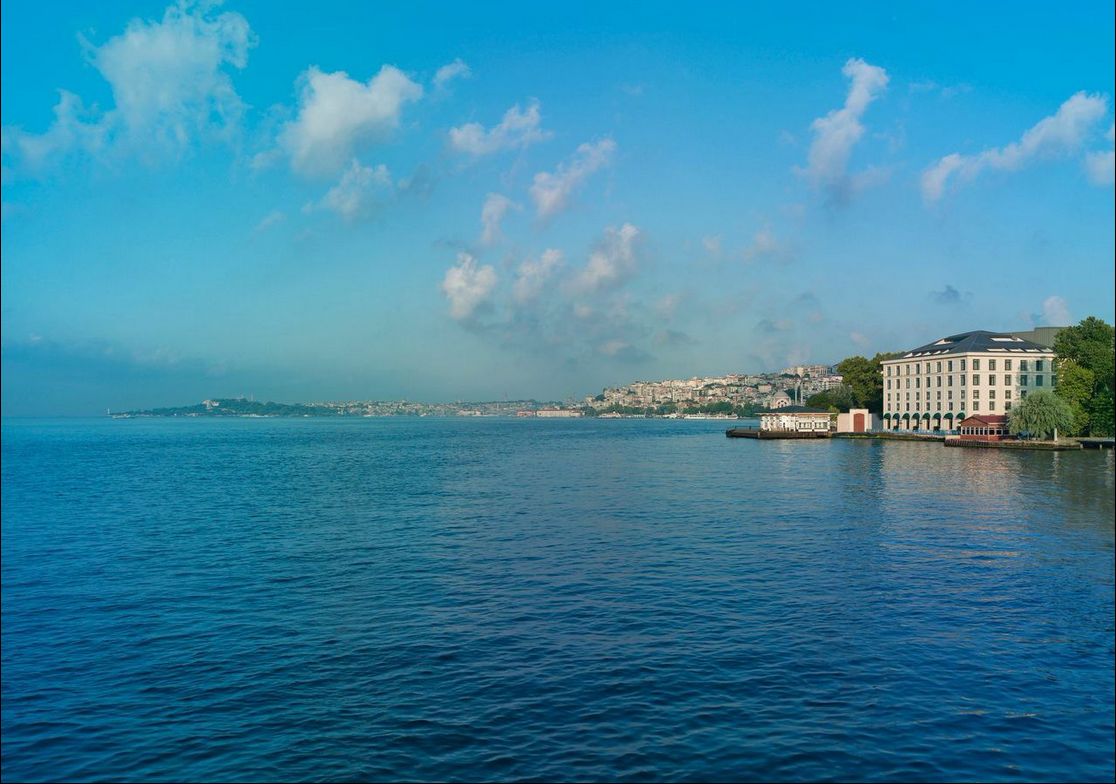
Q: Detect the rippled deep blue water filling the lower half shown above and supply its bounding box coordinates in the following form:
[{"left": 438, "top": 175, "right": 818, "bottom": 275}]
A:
[{"left": 2, "top": 419, "right": 1114, "bottom": 781}]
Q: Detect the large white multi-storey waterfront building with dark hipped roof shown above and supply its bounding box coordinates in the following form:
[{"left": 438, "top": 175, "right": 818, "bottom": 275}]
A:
[{"left": 882, "top": 331, "right": 1055, "bottom": 430}]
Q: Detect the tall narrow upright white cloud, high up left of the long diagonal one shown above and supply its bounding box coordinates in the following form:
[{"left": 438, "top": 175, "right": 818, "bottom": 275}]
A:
[{"left": 800, "top": 58, "right": 888, "bottom": 200}]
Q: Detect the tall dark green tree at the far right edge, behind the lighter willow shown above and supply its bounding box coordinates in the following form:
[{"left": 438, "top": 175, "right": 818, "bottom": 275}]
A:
[{"left": 1054, "top": 316, "right": 1116, "bottom": 436}]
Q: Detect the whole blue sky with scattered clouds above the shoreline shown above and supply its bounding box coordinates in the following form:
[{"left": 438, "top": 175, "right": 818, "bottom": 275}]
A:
[{"left": 0, "top": 0, "right": 1116, "bottom": 416}]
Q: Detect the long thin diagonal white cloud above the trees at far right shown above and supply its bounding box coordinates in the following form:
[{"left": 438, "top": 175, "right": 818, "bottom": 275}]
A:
[{"left": 922, "top": 91, "right": 1108, "bottom": 202}]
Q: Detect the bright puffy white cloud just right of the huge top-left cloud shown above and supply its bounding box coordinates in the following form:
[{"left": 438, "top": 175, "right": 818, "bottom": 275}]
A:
[{"left": 279, "top": 66, "right": 423, "bottom": 174}]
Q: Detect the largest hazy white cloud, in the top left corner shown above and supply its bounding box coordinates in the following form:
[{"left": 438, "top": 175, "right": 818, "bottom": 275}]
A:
[{"left": 4, "top": 2, "right": 256, "bottom": 166}]
